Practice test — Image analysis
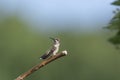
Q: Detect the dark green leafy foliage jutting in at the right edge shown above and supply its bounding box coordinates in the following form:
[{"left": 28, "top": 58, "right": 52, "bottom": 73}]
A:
[{"left": 107, "top": 0, "right": 120, "bottom": 48}]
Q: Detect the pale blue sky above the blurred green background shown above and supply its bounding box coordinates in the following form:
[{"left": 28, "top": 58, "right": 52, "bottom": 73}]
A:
[{"left": 0, "top": 0, "right": 116, "bottom": 30}]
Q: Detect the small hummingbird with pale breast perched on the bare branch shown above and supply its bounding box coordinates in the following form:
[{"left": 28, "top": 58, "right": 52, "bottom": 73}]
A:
[{"left": 40, "top": 37, "right": 60, "bottom": 59}]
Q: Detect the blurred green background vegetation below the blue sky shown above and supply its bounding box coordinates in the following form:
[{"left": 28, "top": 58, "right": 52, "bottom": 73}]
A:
[{"left": 0, "top": 0, "right": 120, "bottom": 80}]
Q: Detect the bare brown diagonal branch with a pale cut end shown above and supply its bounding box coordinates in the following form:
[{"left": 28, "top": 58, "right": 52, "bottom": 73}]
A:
[{"left": 15, "top": 50, "right": 67, "bottom": 80}]
